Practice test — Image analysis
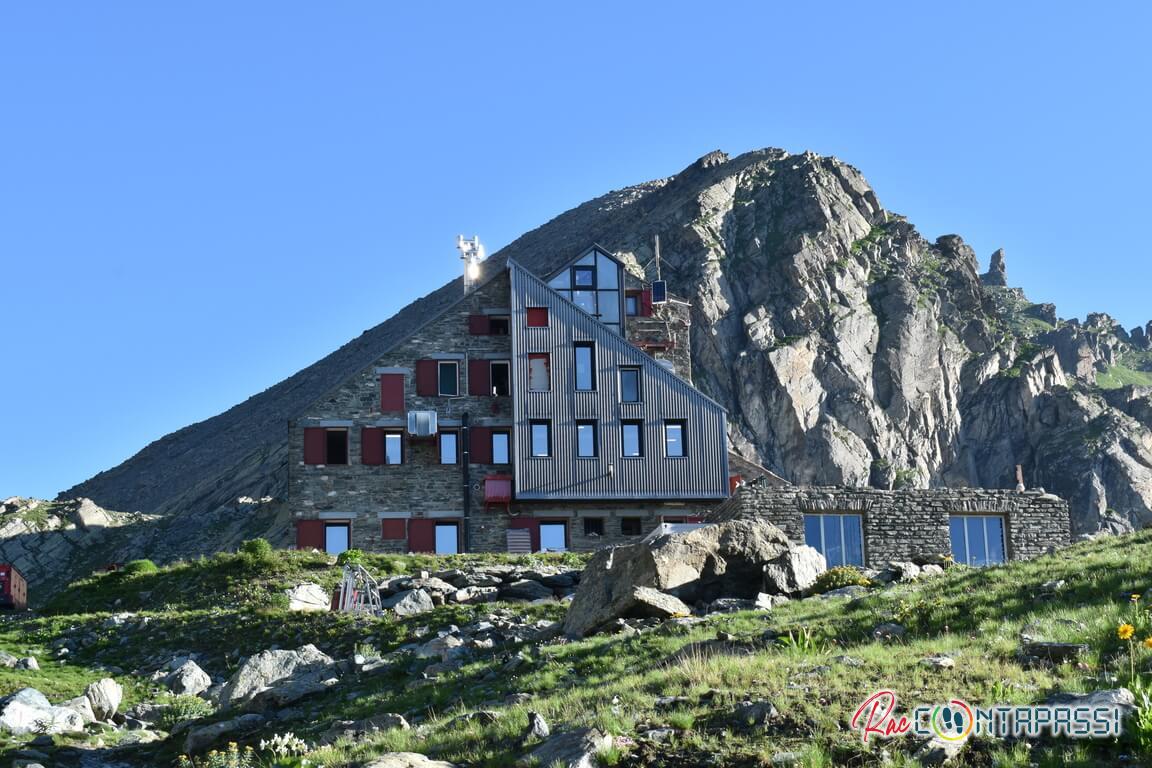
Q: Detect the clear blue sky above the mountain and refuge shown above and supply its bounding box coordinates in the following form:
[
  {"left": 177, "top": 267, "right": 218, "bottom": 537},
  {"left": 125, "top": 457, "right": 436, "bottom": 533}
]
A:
[{"left": 0, "top": 0, "right": 1152, "bottom": 497}]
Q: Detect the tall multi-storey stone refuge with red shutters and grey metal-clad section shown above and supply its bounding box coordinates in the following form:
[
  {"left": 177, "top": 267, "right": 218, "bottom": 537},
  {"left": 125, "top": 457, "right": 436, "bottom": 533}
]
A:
[{"left": 288, "top": 246, "right": 730, "bottom": 553}]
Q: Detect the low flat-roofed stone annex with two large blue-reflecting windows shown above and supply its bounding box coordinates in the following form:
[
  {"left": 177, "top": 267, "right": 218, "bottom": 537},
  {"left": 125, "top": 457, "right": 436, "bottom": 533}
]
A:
[{"left": 707, "top": 478, "right": 1071, "bottom": 568}]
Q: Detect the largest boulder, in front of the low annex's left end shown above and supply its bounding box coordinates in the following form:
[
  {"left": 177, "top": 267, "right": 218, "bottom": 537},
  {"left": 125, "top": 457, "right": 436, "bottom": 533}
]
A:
[{"left": 563, "top": 519, "right": 791, "bottom": 637}]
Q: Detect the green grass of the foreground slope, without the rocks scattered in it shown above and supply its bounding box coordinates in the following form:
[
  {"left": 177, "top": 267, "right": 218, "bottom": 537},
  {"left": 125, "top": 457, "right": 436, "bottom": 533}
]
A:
[{"left": 0, "top": 532, "right": 1152, "bottom": 767}]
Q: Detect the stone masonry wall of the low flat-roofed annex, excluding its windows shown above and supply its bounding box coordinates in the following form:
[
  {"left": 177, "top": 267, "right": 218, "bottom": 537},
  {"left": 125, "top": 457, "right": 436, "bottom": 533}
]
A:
[{"left": 708, "top": 480, "right": 1071, "bottom": 568}]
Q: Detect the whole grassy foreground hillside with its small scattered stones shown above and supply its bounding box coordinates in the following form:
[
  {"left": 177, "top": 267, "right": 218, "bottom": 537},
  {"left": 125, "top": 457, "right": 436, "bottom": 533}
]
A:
[{"left": 0, "top": 532, "right": 1152, "bottom": 768}]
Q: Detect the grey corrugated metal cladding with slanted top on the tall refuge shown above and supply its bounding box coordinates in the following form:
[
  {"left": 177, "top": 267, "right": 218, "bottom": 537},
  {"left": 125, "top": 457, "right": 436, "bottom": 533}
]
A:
[{"left": 509, "top": 263, "right": 728, "bottom": 500}]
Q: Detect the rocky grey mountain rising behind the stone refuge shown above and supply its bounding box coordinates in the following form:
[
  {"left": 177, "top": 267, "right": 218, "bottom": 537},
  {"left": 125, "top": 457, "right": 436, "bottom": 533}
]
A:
[{"left": 56, "top": 149, "right": 1152, "bottom": 534}]
